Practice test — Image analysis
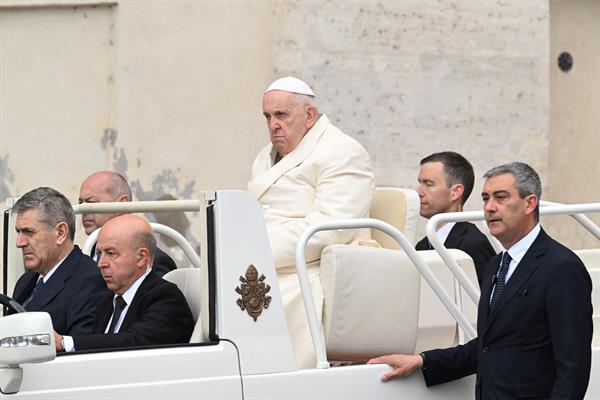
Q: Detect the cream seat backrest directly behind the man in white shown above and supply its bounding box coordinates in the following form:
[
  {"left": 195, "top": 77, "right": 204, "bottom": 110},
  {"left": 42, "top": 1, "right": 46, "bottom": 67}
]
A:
[{"left": 370, "top": 187, "right": 419, "bottom": 249}]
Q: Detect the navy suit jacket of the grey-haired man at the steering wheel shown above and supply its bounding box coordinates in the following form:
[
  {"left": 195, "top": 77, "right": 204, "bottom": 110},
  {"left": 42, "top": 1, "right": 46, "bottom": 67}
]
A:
[{"left": 13, "top": 246, "right": 108, "bottom": 335}]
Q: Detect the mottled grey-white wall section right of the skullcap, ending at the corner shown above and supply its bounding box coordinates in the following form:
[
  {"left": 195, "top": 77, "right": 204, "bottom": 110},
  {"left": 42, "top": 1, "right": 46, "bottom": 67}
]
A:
[{"left": 275, "top": 1, "right": 549, "bottom": 234}]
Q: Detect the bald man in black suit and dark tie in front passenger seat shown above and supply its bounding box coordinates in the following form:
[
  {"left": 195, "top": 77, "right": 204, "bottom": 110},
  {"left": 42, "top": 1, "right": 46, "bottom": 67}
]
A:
[{"left": 55, "top": 214, "right": 194, "bottom": 351}]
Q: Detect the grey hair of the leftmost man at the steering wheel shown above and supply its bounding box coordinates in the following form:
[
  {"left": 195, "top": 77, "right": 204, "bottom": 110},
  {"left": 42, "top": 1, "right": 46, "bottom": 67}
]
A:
[{"left": 12, "top": 187, "right": 75, "bottom": 242}]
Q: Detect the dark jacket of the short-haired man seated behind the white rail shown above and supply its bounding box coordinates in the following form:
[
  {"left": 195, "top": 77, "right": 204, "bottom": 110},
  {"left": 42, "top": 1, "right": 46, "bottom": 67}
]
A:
[{"left": 415, "top": 222, "right": 496, "bottom": 287}]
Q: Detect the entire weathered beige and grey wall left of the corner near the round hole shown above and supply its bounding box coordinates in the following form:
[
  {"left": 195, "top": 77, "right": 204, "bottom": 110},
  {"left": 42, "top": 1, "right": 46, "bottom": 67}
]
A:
[{"left": 0, "top": 0, "right": 596, "bottom": 274}]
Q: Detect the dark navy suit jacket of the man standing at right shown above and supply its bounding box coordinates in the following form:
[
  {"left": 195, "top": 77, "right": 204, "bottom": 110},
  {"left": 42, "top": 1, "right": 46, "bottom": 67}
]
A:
[{"left": 423, "top": 230, "right": 593, "bottom": 400}]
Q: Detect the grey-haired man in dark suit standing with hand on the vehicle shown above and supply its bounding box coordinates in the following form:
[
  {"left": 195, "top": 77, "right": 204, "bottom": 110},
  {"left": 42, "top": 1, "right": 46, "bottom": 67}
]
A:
[{"left": 369, "top": 162, "right": 593, "bottom": 400}]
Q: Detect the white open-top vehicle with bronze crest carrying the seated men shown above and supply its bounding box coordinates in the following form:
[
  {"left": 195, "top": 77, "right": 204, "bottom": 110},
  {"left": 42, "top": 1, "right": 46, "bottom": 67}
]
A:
[{"left": 0, "top": 188, "right": 600, "bottom": 400}]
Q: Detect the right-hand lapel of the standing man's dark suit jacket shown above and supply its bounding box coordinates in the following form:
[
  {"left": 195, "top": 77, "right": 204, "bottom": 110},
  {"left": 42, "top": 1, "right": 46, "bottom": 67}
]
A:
[{"left": 486, "top": 229, "right": 547, "bottom": 331}]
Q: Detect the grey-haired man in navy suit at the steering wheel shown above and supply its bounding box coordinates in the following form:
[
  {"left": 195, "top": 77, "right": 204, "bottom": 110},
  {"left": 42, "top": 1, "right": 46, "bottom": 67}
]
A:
[{"left": 12, "top": 187, "right": 107, "bottom": 335}]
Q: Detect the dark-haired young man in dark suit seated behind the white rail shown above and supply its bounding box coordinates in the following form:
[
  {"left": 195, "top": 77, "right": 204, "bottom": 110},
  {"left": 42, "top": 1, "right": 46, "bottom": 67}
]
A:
[{"left": 415, "top": 151, "right": 496, "bottom": 287}]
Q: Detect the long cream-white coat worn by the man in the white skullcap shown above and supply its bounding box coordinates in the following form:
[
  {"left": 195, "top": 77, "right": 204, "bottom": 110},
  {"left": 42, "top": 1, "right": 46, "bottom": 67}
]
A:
[{"left": 248, "top": 114, "right": 375, "bottom": 368}]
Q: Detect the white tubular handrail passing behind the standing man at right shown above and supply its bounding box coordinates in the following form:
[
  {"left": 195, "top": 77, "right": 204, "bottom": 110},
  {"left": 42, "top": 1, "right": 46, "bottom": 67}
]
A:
[{"left": 426, "top": 202, "right": 600, "bottom": 304}]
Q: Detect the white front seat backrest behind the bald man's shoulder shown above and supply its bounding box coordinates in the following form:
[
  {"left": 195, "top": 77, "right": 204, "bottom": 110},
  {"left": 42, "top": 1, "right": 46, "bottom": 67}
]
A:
[{"left": 163, "top": 268, "right": 203, "bottom": 342}]
